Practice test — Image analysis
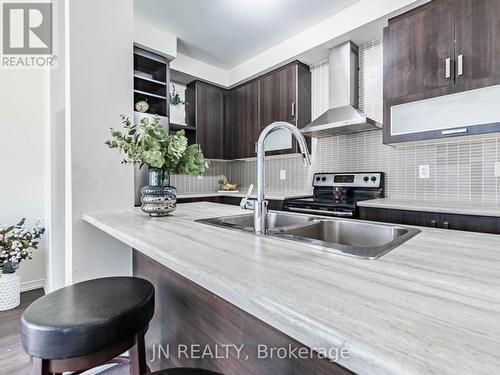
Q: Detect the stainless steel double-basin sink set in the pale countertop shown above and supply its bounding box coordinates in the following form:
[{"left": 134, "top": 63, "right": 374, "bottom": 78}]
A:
[{"left": 196, "top": 211, "right": 420, "bottom": 259}]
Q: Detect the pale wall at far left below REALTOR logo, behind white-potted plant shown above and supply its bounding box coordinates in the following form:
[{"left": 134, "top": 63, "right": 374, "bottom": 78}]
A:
[{"left": 0, "top": 69, "right": 47, "bottom": 289}]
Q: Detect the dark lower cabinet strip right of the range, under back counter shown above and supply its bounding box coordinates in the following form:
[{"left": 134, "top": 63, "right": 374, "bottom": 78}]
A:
[{"left": 359, "top": 207, "right": 500, "bottom": 234}]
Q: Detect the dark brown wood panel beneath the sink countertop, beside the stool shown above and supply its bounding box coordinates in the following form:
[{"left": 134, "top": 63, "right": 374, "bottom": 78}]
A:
[{"left": 133, "top": 250, "right": 352, "bottom": 375}]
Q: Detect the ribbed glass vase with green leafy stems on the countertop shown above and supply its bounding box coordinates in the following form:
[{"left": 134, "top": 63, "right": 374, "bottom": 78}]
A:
[{"left": 106, "top": 116, "right": 209, "bottom": 216}]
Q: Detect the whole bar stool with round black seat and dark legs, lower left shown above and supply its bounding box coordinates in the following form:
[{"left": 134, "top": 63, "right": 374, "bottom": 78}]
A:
[{"left": 21, "top": 277, "right": 155, "bottom": 375}]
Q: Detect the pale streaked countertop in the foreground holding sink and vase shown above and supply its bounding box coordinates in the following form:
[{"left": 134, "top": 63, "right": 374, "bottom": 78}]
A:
[{"left": 84, "top": 202, "right": 500, "bottom": 375}]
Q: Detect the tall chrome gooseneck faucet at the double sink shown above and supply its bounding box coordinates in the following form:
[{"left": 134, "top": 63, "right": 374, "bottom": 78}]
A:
[{"left": 241, "top": 122, "right": 311, "bottom": 236}]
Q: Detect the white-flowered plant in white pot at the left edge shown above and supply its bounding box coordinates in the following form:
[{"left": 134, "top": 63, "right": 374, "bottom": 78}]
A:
[{"left": 0, "top": 219, "right": 45, "bottom": 311}]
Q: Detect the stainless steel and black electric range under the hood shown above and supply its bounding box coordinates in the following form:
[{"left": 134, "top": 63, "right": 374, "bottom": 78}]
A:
[{"left": 283, "top": 172, "right": 384, "bottom": 218}]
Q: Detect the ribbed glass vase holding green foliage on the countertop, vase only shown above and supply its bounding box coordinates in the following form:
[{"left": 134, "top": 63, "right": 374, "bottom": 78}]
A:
[{"left": 141, "top": 169, "right": 177, "bottom": 217}]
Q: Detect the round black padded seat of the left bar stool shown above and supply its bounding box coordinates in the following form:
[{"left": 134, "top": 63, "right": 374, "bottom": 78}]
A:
[{"left": 21, "top": 277, "right": 154, "bottom": 359}]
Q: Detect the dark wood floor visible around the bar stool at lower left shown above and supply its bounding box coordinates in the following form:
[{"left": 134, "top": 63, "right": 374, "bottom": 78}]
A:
[{"left": 0, "top": 289, "right": 129, "bottom": 375}]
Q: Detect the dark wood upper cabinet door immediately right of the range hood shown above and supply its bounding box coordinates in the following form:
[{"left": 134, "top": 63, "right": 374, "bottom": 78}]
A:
[{"left": 384, "top": 0, "right": 455, "bottom": 101}]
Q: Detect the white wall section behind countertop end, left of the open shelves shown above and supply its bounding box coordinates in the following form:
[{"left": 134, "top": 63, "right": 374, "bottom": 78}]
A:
[{"left": 65, "top": 0, "right": 134, "bottom": 283}]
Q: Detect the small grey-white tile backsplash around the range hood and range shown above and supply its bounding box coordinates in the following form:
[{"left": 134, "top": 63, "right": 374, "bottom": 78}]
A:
[{"left": 172, "top": 39, "right": 500, "bottom": 203}]
